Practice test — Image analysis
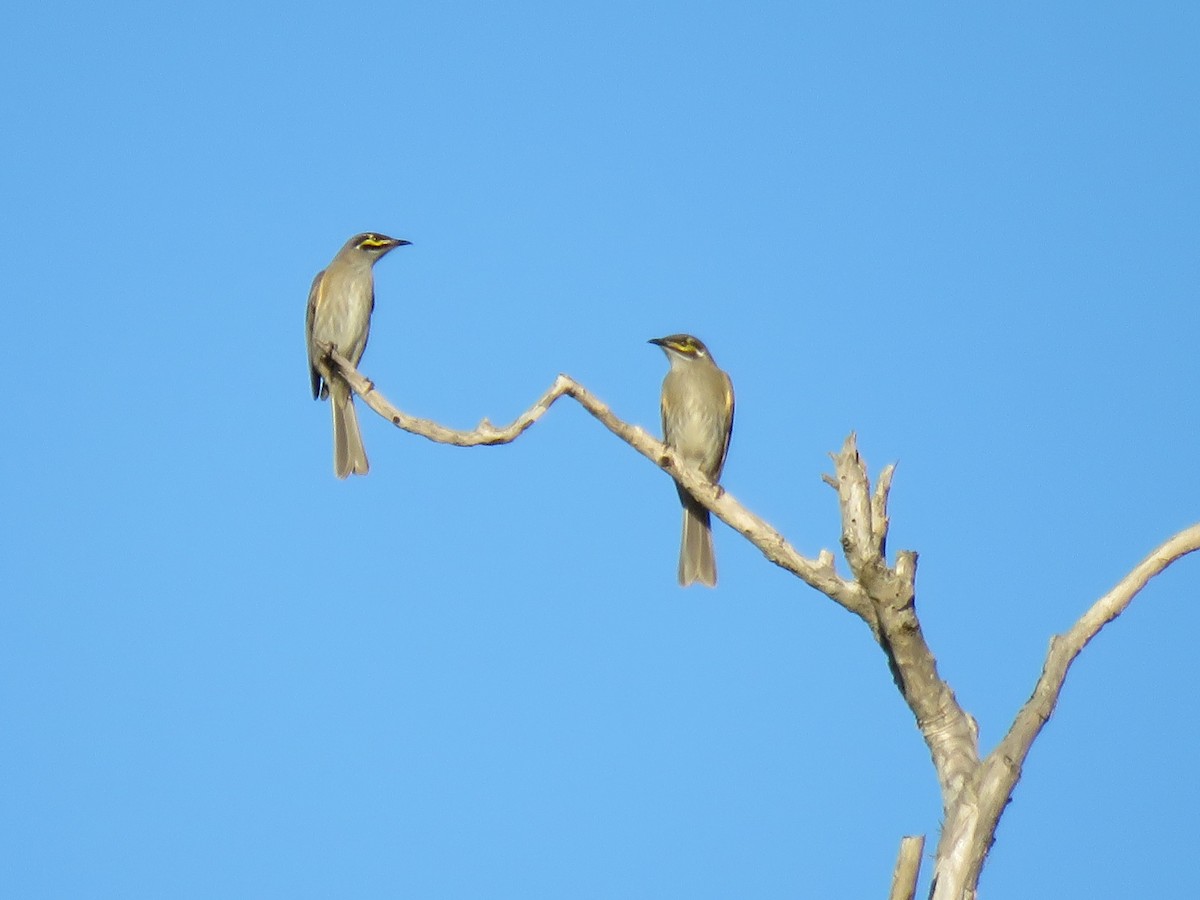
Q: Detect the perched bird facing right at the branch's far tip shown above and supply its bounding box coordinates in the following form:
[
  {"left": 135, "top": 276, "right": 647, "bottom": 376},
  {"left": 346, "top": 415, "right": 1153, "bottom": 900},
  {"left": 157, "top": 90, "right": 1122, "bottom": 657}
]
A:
[{"left": 305, "top": 232, "right": 409, "bottom": 478}]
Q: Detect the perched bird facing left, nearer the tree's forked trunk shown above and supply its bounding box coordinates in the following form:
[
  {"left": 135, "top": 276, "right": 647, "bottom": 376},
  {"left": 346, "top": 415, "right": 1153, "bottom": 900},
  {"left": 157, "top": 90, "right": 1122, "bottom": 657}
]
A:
[{"left": 650, "top": 335, "right": 733, "bottom": 588}]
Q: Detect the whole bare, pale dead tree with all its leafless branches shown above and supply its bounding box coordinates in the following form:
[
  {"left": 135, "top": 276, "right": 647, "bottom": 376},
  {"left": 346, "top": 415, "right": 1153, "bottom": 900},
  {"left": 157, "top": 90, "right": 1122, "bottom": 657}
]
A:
[{"left": 326, "top": 348, "right": 1200, "bottom": 900}]
